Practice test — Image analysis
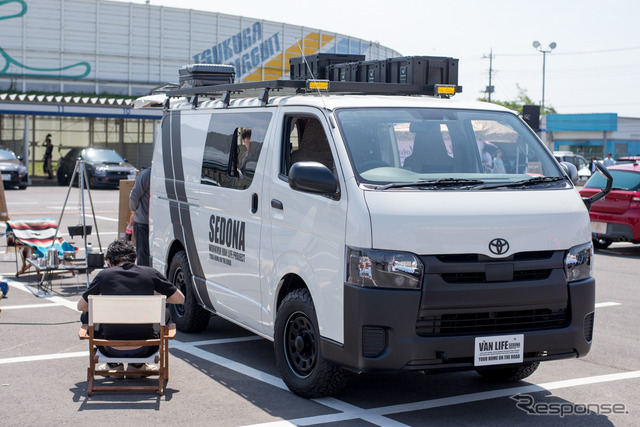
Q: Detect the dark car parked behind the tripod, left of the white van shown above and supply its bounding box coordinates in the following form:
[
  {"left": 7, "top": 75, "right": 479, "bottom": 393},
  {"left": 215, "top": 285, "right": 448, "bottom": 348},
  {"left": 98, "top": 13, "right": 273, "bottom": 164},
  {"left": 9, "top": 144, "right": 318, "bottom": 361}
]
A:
[{"left": 58, "top": 147, "right": 137, "bottom": 188}]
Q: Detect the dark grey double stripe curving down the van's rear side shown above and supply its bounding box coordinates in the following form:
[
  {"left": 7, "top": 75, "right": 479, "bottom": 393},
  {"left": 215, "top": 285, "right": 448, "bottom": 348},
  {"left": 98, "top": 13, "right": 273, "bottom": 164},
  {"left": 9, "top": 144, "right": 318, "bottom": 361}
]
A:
[{"left": 162, "top": 111, "right": 213, "bottom": 308}]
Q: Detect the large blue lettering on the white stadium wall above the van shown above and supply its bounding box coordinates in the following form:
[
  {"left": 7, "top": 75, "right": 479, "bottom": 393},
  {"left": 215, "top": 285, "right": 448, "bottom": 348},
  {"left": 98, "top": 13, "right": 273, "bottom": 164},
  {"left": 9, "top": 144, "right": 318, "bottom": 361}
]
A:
[{"left": 193, "top": 22, "right": 281, "bottom": 77}]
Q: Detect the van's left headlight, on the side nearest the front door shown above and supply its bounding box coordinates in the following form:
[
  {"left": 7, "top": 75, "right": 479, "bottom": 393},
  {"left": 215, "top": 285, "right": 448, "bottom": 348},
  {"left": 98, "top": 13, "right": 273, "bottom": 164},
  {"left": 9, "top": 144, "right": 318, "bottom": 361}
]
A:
[{"left": 347, "top": 248, "right": 424, "bottom": 289}]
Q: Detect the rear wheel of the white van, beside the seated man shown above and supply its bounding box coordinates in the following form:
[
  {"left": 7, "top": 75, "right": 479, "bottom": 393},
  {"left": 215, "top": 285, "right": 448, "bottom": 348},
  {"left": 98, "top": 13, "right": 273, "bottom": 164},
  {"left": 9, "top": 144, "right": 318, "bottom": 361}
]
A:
[{"left": 169, "top": 251, "right": 211, "bottom": 332}]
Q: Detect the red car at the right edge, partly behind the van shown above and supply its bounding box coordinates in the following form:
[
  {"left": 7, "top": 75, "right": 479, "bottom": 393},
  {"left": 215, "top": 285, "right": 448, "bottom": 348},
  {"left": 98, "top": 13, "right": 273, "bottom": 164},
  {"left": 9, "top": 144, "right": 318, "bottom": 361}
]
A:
[{"left": 580, "top": 162, "right": 640, "bottom": 248}]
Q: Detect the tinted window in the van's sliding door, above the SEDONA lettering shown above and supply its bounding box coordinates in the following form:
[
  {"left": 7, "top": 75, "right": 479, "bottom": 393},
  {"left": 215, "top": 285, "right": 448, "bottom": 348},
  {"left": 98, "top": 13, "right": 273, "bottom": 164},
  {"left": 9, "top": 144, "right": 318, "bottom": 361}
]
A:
[{"left": 200, "top": 113, "right": 271, "bottom": 190}]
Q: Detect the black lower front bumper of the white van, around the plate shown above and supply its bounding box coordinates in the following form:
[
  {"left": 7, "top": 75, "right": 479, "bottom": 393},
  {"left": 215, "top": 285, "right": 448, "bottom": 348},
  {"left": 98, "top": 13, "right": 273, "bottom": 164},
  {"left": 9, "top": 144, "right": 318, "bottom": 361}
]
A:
[{"left": 321, "top": 278, "right": 595, "bottom": 372}]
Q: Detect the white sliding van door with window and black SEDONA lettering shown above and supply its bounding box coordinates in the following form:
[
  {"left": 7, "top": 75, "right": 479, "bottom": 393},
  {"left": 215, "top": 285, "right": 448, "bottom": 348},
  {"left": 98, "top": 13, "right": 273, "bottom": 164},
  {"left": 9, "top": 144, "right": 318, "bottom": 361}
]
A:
[{"left": 196, "top": 110, "right": 272, "bottom": 333}]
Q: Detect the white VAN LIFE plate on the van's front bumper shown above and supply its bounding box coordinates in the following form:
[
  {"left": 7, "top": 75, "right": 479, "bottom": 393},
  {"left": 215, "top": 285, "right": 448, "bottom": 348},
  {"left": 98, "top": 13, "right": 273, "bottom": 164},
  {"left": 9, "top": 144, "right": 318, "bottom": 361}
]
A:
[{"left": 473, "top": 334, "right": 524, "bottom": 366}]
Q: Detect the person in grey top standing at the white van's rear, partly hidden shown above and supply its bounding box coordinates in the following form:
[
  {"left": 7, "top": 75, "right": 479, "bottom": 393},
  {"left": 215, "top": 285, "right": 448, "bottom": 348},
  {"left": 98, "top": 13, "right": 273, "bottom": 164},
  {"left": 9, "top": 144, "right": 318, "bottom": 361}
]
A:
[{"left": 129, "top": 167, "right": 151, "bottom": 266}]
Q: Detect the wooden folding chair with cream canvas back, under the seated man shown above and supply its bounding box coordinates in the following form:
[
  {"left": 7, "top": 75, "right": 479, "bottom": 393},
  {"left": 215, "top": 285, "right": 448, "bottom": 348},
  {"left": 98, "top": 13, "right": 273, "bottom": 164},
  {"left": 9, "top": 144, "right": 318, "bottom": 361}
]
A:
[{"left": 79, "top": 295, "right": 175, "bottom": 396}]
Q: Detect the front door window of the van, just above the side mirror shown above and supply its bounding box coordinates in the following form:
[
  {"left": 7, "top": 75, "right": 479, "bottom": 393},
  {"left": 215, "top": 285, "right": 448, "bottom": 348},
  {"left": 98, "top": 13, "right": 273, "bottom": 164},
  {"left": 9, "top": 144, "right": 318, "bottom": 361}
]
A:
[{"left": 281, "top": 117, "right": 334, "bottom": 175}]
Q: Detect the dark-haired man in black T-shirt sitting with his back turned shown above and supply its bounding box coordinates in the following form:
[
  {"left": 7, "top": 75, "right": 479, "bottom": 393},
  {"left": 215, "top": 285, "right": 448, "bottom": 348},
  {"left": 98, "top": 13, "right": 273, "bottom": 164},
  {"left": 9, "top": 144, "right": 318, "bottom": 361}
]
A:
[{"left": 78, "top": 240, "right": 184, "bottom": 371}]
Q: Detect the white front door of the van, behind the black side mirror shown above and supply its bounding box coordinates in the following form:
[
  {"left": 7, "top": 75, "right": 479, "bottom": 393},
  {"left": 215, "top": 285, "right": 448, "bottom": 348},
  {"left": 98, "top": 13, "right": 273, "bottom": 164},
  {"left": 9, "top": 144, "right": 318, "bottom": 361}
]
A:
[{"left": 263, "top": 107, "right": 347, "bottom": 342}]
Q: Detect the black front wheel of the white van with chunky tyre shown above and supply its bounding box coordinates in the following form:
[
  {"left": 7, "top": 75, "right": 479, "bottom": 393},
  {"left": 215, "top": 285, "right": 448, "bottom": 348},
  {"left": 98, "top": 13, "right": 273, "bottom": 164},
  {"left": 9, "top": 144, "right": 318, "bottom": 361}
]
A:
[{"left": 274, "top": 289, "right": 347, "bottom": 398}]
